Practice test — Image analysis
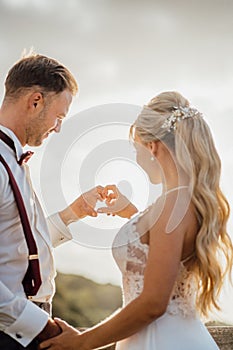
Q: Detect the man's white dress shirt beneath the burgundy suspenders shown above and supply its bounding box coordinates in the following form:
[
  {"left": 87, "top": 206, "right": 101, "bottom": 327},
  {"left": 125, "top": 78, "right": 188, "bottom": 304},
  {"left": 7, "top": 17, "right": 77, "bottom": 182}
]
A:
[{"left": 0, "top": 126, "right": 72, "bottom": 346}]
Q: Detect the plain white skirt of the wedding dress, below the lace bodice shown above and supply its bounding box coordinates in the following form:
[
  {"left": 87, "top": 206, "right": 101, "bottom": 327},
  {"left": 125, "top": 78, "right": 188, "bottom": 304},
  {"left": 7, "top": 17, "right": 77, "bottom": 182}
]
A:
[{"left": 116, "top": 313, "right": 219, "bottom": 350}]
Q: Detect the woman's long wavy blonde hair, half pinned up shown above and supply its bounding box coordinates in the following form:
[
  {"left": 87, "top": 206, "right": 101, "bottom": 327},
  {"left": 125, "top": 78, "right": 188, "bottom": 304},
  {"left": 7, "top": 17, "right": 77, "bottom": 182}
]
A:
[{"left": 131, "top": 91, "right": 233, "bottom": 316}]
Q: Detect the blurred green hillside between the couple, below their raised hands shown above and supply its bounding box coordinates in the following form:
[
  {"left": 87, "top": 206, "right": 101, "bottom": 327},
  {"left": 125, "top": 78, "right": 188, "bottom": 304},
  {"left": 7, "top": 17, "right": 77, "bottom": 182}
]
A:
[{"left": 53, "top": 273, "right": 121, "bottom": 327}]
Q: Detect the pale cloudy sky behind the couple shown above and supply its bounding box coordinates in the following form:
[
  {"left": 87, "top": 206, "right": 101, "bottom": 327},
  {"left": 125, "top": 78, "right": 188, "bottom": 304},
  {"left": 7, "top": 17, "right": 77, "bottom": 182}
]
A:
[{"left": 0, "top": 0, "right": 233, "bottom": 322}]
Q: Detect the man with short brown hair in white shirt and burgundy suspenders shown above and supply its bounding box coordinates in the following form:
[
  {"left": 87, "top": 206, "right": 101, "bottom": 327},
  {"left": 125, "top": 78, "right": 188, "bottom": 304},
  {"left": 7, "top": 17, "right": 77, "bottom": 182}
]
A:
[{"left": 0, "top": 54, "right": 102, "bottom": 350}]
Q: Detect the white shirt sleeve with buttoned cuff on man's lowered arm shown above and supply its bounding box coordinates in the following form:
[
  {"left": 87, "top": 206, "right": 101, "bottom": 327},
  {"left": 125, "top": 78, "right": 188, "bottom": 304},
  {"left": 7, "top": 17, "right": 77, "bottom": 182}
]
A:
[{"left": 0, "top": 282, "right": 49, "bottom": 347}]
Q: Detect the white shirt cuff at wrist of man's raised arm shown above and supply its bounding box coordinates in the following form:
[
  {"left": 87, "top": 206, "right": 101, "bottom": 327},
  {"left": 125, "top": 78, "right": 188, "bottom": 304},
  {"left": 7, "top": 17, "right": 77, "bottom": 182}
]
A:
[{"left": 47, "top": 213, "right": 73, "bottom": 247}]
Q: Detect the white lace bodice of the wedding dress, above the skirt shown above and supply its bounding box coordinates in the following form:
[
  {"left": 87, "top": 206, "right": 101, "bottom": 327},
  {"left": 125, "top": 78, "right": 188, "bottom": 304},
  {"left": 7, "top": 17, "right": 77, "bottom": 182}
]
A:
[{"left": 113, "top": 209, "right": 196, "bottom": 317}]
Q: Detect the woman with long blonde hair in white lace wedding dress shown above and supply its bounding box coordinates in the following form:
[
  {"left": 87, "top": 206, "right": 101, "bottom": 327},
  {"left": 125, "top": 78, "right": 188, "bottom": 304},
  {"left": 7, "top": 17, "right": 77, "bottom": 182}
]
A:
[{"left": 40, "top": 92, "right": 233, "bottom": 350}]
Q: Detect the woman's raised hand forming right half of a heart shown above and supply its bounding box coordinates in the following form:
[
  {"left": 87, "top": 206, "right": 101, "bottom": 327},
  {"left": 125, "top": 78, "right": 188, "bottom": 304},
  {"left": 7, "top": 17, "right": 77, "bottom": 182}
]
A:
[{"left": 97, "top": 185, "right": 138, "bottom": 219}]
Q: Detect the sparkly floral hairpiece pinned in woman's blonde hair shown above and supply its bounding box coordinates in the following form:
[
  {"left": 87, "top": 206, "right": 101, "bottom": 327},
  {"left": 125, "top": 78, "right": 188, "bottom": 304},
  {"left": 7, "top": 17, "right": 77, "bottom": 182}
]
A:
[{"left": 162, "top": 107, "right": 202, "bottom": 132}]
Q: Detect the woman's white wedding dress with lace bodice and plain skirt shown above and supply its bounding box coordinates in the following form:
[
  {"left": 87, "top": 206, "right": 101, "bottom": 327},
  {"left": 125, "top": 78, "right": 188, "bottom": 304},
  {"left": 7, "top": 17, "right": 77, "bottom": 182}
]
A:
[{"left": 113, "top": 209, "right": 219, "bottom": 350}]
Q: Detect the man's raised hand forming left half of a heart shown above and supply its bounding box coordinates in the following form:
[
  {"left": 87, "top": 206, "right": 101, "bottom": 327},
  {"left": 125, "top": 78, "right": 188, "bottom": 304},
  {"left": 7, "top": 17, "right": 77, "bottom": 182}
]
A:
[{"left": 59, "top": 186, "right": 104, "bottom": 225}]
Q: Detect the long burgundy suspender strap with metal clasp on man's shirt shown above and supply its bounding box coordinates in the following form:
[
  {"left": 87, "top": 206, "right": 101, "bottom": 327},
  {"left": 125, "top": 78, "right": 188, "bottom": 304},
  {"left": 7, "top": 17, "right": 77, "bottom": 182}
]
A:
[{"left": 0, "top": 155, "right": 42, "bottom": 297}]
